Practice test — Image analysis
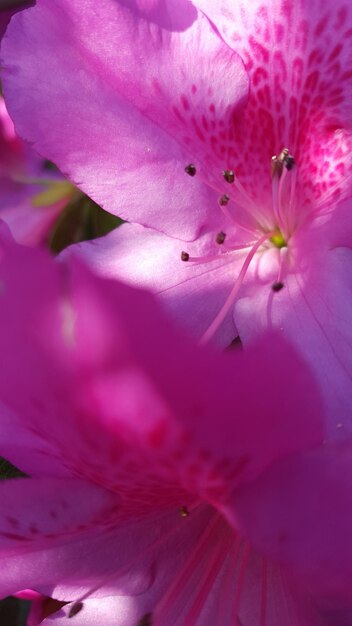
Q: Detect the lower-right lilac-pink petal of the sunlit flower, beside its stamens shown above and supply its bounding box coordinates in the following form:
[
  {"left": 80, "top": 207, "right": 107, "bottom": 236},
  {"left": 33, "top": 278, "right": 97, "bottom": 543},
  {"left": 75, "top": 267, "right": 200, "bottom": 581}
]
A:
[{"left": 235, "top": 246, "right": 352, "bottom": 438}]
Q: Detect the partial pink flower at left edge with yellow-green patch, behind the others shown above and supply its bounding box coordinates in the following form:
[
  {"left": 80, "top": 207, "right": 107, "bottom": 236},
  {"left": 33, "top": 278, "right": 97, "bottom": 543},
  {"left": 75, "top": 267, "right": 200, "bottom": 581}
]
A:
[{"left": 0, "top": 98, "right": 77, "bottom": 245}]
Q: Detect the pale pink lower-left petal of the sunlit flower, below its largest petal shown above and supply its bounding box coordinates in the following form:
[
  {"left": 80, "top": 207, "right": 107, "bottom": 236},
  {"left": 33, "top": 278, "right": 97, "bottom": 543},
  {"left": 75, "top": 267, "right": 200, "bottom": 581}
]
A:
[{"left": 61, "top": 224, "right": 237, "bottom": 347}]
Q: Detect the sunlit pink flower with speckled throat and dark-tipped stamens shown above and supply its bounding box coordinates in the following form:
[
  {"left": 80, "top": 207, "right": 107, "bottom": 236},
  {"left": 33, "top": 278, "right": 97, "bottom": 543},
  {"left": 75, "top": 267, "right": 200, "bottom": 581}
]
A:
[{"left": 2, "top": 0, "right": 352, "bottom": 438}]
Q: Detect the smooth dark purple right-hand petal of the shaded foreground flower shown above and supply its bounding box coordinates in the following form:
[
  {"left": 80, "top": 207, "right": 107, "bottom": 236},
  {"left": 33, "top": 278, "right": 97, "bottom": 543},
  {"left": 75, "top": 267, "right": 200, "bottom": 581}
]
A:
[{"left": 234, "top": 442, "right": 352, "bottom": 610}]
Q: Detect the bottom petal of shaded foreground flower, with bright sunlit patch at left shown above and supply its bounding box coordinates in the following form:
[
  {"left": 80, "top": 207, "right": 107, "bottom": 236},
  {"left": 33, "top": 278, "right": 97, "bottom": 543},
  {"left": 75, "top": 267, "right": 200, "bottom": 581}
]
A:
[{"left": 40, "top": 515, "right": 322, "bottom": 626}]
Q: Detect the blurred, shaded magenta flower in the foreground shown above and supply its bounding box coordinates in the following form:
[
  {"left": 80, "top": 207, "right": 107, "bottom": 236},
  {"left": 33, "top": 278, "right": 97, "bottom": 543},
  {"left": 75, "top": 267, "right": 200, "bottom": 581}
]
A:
[{"left": 0, "top": 233, "right": 338, "bottom": 626}]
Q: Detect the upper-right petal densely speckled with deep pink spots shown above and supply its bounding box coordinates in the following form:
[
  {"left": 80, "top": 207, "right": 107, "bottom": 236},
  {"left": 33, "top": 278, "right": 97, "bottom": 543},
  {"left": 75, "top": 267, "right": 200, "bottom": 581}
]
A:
[{"left": 195, "top": 0, "right": 352, "bottom": 224}]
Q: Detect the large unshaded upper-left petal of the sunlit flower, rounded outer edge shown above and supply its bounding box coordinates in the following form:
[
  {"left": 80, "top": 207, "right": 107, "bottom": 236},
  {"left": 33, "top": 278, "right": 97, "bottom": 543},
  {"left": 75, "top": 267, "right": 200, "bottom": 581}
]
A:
[{"left": 2, "top": 0, "right": 248, "bottom": 239}]
